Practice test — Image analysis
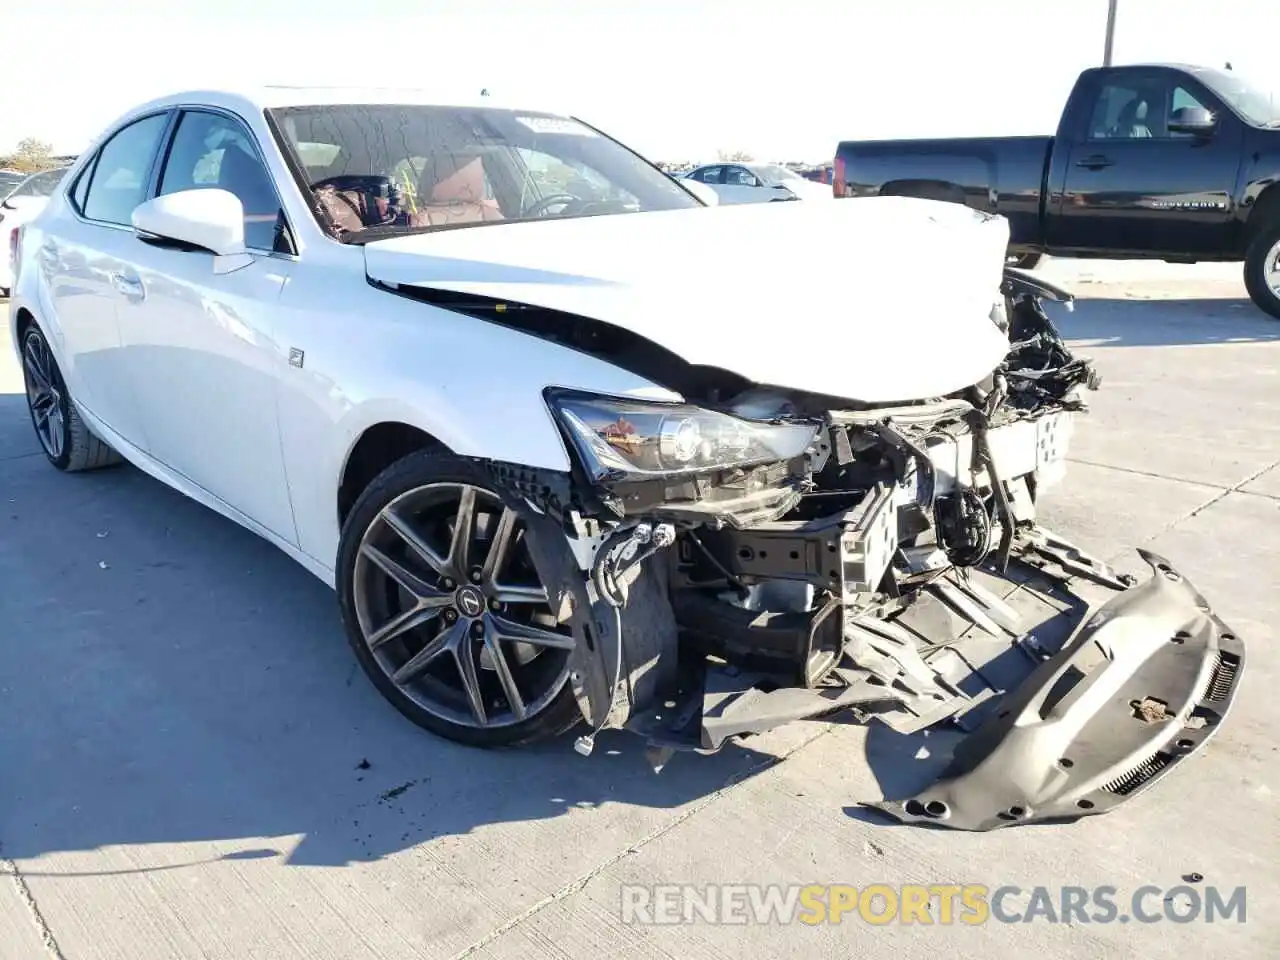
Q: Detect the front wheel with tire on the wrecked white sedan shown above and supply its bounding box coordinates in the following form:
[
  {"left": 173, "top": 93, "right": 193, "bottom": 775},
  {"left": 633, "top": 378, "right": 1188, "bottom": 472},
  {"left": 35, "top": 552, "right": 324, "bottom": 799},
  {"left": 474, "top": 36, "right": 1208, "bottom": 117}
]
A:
[{"left": 337, "top": 452, "right": 580, "bottom": 746}]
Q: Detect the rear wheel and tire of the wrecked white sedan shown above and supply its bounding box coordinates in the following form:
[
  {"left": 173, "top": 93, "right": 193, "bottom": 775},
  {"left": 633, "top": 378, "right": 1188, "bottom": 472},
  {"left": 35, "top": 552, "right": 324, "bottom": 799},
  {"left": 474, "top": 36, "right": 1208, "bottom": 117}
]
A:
[{"left": 22, "top": 324, "right": 120, "bottom": 474}]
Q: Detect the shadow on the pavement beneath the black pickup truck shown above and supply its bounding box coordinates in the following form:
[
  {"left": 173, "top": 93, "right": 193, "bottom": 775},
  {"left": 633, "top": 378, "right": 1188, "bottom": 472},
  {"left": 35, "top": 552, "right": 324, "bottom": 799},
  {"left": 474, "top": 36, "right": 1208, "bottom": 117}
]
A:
[{"left": 1048, "top": 298, "right": 1280, "bottom": 351}]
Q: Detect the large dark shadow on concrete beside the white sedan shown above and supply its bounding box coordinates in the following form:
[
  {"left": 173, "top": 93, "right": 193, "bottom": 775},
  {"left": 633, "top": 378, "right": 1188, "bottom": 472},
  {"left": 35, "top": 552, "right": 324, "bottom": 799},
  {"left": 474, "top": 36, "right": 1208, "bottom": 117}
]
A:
[{"left": 0, "top": 396, "right": 773, "bottom": 872}]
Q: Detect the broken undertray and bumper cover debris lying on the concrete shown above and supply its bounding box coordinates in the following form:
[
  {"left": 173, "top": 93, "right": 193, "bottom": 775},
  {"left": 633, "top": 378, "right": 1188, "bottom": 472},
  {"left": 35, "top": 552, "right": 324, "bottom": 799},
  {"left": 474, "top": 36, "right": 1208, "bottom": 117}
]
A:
[{"left": 628, "top": 537, "right": 1244, "bottom": 831}]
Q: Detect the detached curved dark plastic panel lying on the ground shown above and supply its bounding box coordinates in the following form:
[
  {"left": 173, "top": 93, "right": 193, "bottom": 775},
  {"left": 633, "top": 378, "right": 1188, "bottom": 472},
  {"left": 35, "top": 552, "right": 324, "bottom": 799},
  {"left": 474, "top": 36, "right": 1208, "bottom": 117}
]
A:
[{"left": 864, "top": 550, "right": 1244, "bottom": 831}]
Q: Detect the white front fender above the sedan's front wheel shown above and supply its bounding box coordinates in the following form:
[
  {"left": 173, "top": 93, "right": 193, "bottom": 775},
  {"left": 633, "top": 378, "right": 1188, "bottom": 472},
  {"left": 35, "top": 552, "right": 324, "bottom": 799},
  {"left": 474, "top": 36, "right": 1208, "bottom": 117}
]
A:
[{"left": 280, "top": 281, "right": 678, "bottom": 576}]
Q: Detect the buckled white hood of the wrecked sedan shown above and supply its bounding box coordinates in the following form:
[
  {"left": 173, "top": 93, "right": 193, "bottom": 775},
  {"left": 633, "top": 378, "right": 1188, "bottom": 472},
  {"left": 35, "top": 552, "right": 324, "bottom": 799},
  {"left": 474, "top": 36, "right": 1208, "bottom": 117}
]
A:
[{"left": 365, "top": 197, "right": 1009, "bottom": 403}]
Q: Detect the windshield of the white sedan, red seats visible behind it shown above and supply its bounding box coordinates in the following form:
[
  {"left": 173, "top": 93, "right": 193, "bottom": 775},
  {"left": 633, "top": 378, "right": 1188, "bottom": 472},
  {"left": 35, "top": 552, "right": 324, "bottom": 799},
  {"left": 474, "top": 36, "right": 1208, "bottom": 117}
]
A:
[{"left": 263, "top": 105, "right": 699, "bottom": 242}]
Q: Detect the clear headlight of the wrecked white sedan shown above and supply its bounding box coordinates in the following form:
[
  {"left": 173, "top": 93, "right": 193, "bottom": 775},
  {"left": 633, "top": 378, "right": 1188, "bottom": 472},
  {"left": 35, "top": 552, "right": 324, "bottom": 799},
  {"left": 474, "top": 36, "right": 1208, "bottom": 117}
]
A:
[{"left": 548, "top": 392, "right": 818, "bottom": 480}]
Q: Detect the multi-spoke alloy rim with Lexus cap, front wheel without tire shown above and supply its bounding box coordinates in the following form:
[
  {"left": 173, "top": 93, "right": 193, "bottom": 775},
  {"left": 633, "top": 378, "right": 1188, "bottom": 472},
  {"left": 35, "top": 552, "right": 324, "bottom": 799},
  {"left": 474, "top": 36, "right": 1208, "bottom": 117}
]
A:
[{"left": 352, "top": 483, "right": 573, "bottom": 728}]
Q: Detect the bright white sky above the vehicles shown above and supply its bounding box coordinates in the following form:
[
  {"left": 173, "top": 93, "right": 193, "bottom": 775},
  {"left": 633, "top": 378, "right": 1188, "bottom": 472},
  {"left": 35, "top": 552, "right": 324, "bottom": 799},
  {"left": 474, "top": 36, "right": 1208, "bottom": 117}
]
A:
[{"left": 0, "top": 0, "right": 1280, "bottom": 160}]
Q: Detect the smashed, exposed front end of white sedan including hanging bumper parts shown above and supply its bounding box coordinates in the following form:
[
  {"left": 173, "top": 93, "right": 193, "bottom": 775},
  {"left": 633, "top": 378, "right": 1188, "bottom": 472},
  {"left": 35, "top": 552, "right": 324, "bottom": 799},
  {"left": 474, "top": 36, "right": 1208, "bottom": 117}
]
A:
[{"left": 492, "top": 269, "right": 1244, "bottom": 829}]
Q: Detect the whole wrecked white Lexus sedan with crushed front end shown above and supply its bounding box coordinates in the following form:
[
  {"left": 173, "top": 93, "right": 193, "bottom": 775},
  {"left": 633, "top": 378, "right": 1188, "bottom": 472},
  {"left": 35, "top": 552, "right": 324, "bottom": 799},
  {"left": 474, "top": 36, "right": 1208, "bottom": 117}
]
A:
[{"left": 10, "top": 88, "right": 1244, "bottom": 829}]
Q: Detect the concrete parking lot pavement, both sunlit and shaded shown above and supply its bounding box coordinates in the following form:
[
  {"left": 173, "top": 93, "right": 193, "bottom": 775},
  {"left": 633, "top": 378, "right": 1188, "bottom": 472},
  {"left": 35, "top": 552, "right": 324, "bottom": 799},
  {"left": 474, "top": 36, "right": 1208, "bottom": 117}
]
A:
[{"left": 0, "top": 262, "right": 1280, "bottom": 960}]
